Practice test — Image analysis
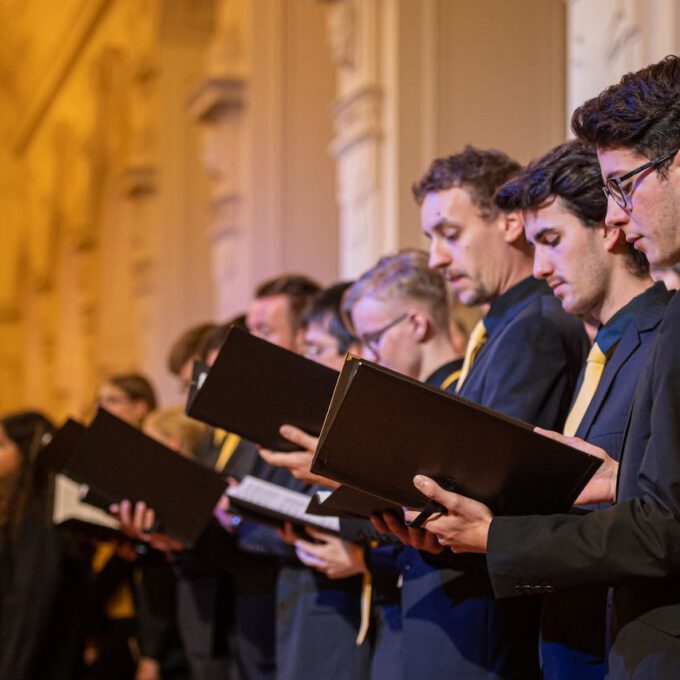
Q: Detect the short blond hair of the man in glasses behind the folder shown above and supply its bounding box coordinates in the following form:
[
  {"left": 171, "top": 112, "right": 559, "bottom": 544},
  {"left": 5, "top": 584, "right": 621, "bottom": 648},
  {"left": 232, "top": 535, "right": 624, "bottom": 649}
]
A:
[{"left": 342, "top": 249, "right": 449, "bottom": 334}]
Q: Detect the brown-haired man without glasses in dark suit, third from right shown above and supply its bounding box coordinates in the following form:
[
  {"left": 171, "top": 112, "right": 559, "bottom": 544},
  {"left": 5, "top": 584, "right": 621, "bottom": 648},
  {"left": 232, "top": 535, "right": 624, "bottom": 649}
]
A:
[{"left": 370, "top": 147, "right": 587, "bottom": 680}]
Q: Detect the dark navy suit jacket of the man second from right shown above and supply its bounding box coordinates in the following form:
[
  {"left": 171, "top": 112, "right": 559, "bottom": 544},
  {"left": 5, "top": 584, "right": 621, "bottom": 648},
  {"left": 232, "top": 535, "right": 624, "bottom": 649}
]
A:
[{"left": 541, "top": 284, "right": 672, "bottom": 680}]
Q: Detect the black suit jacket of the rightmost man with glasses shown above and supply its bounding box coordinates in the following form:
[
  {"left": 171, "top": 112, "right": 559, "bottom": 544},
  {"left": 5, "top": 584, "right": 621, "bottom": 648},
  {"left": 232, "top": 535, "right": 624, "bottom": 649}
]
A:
[{"left": 487, "top": 288, "right": 680, "bottom": 679}]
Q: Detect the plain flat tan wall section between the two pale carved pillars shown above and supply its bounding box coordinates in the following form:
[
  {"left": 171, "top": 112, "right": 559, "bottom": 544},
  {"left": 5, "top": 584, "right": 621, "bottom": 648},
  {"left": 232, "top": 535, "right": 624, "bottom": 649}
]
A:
[{"left": 399, "top": 0, "right": 566, "bottom": 250}]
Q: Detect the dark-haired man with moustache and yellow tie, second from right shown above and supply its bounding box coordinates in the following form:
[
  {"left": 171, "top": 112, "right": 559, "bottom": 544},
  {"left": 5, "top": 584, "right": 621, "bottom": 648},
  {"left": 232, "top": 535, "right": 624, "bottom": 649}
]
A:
[{"left": 496, "top": 141, "right": 671, "bottom": 680}]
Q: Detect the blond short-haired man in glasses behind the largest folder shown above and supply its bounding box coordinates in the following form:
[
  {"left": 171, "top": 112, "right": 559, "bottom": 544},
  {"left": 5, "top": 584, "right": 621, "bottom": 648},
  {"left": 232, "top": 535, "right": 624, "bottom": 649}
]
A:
[{"left": 284, "top": 250, "right": 461, "bottom": 680}]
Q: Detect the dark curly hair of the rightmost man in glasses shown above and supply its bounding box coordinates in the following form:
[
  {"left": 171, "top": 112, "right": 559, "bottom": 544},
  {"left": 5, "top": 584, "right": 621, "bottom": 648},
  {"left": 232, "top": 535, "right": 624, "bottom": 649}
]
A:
[{"left": 571, "top": 55, "right": 680, "bottom": 166}]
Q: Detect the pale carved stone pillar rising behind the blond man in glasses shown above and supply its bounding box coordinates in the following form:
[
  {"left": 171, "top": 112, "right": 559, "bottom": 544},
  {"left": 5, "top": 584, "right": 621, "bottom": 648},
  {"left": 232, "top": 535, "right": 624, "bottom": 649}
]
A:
[{"left": 326, "top": 0, "right": 439, "bottom": 277}]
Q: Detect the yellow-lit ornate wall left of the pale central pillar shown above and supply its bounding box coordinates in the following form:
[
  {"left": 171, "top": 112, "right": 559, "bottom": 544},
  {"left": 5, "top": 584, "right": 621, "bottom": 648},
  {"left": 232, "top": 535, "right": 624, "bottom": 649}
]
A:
[{"left": 0, "top": 0, "right": 338, "bottom": 417}]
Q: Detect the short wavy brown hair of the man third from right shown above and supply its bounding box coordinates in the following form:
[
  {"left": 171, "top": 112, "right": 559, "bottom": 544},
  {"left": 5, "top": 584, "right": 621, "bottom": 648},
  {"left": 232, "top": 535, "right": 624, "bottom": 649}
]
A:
[{"left": 412, "top": 144, "right": 521, "bottom": 220}]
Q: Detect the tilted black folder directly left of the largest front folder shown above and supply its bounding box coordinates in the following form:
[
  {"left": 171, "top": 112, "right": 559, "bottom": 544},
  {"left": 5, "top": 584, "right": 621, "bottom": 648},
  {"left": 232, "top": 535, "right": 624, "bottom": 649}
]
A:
[{"left": 187, "top": 326, "right": 338, "bottom": 451}]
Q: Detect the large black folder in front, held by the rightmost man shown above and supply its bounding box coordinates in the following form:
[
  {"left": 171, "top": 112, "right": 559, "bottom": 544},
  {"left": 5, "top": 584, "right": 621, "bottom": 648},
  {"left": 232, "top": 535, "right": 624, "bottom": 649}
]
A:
[{"left": 312, "top": 357, "right": 602, "bottom": 515}]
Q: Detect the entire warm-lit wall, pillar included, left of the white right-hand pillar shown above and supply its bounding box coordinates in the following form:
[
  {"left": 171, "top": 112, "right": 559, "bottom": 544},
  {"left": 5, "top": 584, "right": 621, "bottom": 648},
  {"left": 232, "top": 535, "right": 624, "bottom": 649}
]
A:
[{"left": 9, "top": 0, "right": 644, "bottom": 416}]
